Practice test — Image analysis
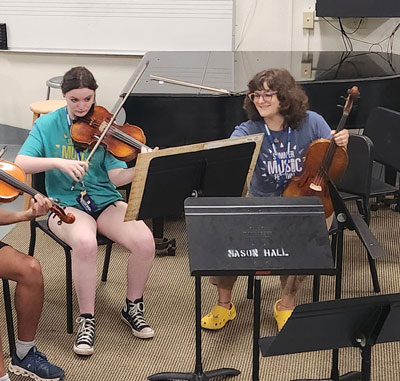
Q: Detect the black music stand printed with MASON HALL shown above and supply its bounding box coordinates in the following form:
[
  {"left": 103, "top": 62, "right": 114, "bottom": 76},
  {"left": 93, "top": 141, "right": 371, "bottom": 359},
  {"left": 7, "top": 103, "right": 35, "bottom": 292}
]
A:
[{"left": 148, "top": 197, "right": 335, "bottom": 381}]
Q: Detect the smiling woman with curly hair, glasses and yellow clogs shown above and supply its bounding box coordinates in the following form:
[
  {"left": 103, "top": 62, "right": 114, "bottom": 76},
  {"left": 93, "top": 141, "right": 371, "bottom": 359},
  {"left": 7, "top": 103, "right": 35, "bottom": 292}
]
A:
[{"left": 201, "top": 69, "right": 349, "bottom": 330}]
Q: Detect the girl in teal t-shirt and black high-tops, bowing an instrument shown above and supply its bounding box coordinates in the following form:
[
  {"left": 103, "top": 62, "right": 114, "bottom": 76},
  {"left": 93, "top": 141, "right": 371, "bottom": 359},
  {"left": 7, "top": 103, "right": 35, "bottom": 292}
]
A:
[{"left": 15, "top": 67, "right": 155, "bottom": 355}]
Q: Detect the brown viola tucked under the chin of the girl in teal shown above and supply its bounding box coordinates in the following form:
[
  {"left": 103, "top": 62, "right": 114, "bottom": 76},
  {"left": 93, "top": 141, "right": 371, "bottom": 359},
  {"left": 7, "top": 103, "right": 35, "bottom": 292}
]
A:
[{"left": 71, "top": 106, "right": 150, "bottom": 161}]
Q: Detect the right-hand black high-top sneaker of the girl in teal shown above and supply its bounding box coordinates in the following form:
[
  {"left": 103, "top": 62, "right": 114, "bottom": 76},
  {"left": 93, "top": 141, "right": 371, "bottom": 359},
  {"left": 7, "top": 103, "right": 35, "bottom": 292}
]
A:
[{"left": 121, "top": 298, "right": 154, "bottom": 339}]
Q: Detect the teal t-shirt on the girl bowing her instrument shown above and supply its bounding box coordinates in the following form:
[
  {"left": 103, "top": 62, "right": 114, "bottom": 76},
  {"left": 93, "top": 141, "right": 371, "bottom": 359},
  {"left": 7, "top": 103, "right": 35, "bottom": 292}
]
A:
[{"left": 19, "top": 108, "right": 127, "bottom": 210}]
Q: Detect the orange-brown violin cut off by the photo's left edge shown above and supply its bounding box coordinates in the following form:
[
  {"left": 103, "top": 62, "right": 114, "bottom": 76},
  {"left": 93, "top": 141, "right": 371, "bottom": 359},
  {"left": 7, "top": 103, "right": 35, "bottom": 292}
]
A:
[{"left": 0, "top": 160, "right": 75, "bottom": 224}]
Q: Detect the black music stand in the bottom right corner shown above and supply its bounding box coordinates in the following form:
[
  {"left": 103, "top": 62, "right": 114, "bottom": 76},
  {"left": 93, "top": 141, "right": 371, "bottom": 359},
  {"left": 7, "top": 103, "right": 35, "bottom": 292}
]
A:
[{"left": 259, "top": 294, "right": 400, "bottom": 381}]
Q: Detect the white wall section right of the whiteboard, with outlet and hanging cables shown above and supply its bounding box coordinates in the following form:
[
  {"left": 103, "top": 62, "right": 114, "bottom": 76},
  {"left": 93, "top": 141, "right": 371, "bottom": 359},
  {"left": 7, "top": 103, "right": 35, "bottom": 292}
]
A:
[{"left": 235, "top": 0, "right": 400, "bottom": 53}]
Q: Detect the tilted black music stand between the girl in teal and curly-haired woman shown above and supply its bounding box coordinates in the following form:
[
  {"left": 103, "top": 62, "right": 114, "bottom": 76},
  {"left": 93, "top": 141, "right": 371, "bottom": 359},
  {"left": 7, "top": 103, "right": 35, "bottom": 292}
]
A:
[{"left": 145, "top": 141, "right": 256, "bottom": 381}]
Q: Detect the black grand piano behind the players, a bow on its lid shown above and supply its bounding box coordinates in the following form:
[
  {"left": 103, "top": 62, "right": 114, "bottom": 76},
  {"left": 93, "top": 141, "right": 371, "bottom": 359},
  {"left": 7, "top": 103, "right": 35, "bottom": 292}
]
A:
[{"left": 114, "top": 51, "right": 400, "bottom": 147}]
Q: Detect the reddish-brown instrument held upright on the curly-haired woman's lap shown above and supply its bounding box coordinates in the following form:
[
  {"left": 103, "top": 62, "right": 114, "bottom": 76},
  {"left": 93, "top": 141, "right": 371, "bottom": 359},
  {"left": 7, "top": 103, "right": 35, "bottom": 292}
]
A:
[{"left": 283, "top": 86, "right": 360, "bottom": 217}]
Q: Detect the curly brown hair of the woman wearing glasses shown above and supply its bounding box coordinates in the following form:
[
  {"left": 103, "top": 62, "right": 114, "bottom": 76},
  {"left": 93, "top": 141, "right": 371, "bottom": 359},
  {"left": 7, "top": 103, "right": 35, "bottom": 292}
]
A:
[{"left": 243, "top": 69, "right": 308, "bottom": 128}]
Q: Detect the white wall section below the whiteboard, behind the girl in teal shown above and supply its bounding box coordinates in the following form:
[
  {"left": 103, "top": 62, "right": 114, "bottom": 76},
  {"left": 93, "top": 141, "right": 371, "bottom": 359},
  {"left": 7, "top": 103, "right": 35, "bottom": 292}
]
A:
[{"left": 0, "top": 52, "right": 141, "bottom": 129}]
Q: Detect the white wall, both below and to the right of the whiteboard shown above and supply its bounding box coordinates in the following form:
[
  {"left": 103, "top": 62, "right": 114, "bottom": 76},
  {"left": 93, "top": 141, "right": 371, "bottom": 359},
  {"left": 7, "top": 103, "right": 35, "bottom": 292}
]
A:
[{"left": 0, "top": 0, "right": 400, "bottom": 129}]
